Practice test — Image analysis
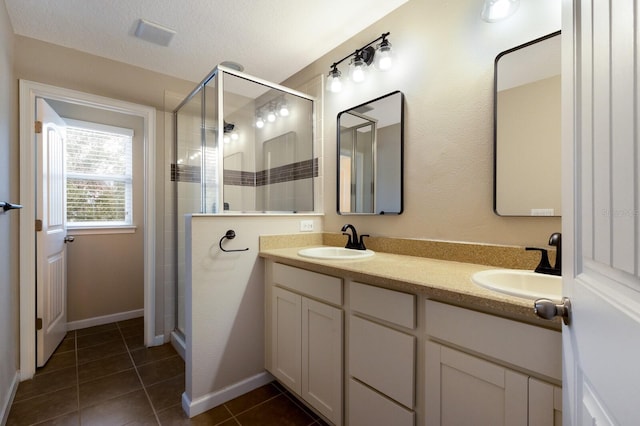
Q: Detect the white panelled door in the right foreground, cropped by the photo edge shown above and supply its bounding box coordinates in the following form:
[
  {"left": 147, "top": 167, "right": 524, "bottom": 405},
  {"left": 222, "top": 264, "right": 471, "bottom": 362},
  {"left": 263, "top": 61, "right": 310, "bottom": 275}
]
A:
[{"left": 562, "top": 0, "right": 640, "bottom": 425}]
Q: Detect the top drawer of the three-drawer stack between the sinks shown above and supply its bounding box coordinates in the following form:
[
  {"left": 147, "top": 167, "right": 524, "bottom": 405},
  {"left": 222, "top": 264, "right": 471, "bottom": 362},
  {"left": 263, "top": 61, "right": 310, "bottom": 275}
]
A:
[{"left": 349, "top": 282, "right": 416, "bottom": 329}]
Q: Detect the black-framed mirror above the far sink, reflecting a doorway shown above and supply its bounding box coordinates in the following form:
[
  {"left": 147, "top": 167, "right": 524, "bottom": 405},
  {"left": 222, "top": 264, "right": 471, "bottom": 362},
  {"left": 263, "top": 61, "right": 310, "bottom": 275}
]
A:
[{"left": 337, "top": 91, "right": 404, "bottom": 215}]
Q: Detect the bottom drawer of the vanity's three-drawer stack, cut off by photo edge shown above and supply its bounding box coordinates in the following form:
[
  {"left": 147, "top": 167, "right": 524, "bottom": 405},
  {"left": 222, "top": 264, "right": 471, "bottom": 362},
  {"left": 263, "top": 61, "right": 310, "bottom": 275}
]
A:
[{"left": 348, "top": 379, "right": 415, "bottom": 426}]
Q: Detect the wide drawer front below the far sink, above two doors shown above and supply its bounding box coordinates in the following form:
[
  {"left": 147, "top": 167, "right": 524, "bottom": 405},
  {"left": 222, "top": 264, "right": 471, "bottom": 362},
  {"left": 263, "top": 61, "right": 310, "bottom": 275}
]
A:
[{"left": 273, "top": 263, "right": 342, "bottom": 305}]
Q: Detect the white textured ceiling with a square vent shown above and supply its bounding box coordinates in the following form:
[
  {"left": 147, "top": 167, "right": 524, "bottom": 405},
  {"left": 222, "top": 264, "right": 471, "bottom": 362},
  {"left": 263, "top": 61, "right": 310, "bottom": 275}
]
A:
[{"left": 5, "top": 0, "right": 407, "bottom": 82}]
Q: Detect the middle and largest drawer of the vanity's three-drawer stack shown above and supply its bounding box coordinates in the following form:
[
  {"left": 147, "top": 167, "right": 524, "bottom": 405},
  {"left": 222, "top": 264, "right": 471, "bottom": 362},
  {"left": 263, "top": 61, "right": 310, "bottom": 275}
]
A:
[{"left": 349, "top": 316, "right": 416, "bottom": 408}]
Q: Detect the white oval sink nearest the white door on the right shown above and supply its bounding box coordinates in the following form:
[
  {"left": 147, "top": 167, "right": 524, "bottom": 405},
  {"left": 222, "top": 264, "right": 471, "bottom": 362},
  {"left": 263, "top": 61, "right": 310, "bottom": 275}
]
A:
[{"left": 471, "top": 269, "right": 562, "bottom": 300}]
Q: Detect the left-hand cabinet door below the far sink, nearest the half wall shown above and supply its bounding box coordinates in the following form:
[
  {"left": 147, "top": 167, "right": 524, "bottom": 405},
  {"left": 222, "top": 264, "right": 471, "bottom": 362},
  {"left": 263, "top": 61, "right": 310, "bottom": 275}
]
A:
[{"left": 271, "top": 287, "right": 302, "bottom": 394}]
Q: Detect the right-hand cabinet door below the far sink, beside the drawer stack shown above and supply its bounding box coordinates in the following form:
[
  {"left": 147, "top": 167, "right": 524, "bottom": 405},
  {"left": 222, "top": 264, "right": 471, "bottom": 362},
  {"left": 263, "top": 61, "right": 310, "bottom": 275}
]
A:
[{"left": 301, "top": 297, "right": 343, "bottom": 425}]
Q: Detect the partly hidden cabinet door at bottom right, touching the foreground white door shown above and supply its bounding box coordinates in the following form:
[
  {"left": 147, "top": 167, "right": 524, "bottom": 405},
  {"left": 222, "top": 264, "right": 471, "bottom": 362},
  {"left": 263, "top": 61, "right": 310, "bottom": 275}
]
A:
[{"left": 529, "top": 378, "right": 562, "bottom": 426}]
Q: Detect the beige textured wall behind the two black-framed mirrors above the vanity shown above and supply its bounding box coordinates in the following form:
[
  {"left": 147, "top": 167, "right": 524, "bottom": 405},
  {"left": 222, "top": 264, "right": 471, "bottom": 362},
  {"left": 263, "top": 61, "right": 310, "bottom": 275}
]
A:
[{"left": 284, "top": 0, "right": 560, "bottom": 246}]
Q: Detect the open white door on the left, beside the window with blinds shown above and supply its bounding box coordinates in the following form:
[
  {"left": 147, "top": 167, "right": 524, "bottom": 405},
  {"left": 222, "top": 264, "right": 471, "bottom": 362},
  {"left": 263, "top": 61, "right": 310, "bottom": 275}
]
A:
[{"left": 36, "top": 98, "right": 67, "bottom": 367}]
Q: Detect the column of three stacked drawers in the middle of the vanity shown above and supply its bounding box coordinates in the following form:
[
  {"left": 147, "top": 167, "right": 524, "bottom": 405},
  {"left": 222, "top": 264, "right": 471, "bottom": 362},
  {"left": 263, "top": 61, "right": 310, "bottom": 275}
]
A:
[{"left": 347, "top": 282, "right": 416, "bottom": 426}]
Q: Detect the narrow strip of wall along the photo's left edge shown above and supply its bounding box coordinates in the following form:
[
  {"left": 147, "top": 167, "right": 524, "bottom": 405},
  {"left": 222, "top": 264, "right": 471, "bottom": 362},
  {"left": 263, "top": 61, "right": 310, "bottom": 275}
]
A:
[{"left": 0, "top": 2, "right": 19, "bottom": 423}]
